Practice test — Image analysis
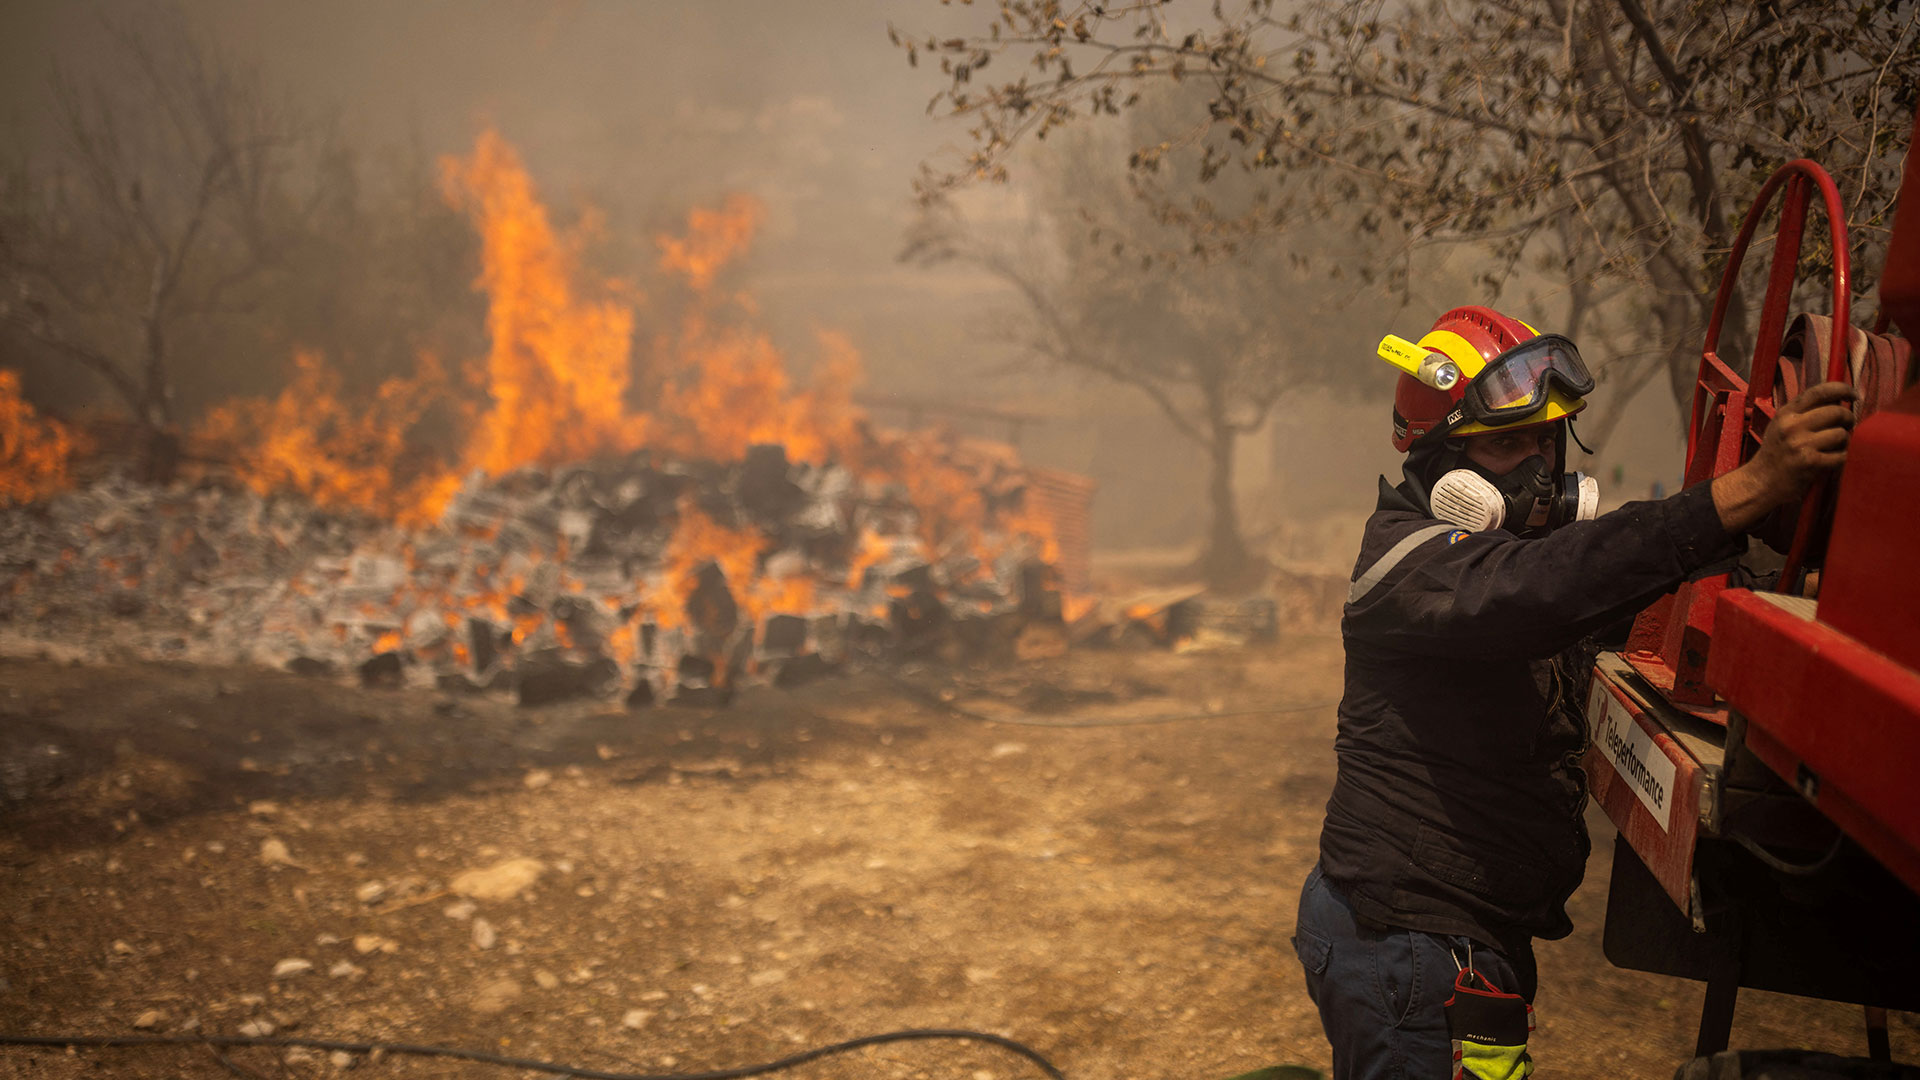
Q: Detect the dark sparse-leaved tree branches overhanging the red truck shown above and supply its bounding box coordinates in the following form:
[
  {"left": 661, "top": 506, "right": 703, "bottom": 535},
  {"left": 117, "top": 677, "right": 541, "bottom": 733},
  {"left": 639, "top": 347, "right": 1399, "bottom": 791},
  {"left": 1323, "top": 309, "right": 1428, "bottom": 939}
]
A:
[{"left": 895, "top": 0, "right": 1920, "bottom": 428}]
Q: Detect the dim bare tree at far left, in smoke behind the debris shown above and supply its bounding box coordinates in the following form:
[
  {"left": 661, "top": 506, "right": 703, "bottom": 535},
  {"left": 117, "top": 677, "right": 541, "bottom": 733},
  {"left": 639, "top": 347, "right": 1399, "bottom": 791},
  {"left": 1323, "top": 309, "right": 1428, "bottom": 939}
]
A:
[{"left": 0, "top": 19, "right": 311, "bottom": 479}]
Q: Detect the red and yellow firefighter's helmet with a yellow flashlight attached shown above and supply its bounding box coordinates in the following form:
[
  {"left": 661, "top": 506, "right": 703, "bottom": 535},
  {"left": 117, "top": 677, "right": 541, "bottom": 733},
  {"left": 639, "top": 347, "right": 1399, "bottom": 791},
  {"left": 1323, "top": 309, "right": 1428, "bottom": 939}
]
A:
[{"left": 1380, "top": 307, "right": 1586, "bottom": 454}]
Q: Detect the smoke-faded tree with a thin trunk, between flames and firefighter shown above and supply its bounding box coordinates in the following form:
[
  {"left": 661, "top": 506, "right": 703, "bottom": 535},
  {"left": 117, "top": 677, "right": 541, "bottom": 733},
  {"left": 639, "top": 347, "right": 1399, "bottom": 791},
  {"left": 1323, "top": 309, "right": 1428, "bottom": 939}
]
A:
[{"left": 900, "top": 117, "right": 1371, "bottom": 588}]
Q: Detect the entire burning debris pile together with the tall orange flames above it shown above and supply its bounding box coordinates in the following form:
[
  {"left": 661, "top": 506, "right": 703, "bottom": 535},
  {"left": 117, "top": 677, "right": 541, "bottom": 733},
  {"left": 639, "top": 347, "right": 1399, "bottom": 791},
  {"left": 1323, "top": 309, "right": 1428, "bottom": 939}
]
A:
[{"left": 0, "top": 133, "right": 1064, "bottom": 705}]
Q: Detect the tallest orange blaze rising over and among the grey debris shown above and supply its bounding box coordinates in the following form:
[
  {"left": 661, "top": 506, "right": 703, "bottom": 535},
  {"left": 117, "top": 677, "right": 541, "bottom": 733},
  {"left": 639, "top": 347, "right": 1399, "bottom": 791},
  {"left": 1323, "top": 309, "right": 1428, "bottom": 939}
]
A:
[{"left": 191, "top": 131, "right": 1050, "bottom": 651}]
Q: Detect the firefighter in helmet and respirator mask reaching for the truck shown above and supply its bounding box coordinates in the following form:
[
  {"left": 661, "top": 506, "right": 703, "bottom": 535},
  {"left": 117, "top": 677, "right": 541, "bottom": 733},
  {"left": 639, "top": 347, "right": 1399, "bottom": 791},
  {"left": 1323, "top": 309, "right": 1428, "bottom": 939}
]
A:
[{"left": 1294, "top": 307, "right": 1853, "bottom": 1080}]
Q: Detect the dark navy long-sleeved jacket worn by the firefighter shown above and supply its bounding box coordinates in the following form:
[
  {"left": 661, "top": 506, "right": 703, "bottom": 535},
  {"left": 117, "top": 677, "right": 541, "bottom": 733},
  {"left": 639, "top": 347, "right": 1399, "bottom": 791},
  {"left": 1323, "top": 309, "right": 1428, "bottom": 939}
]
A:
[{"left": 1321, "top": 482, "right": 1741, "bottom": 945}]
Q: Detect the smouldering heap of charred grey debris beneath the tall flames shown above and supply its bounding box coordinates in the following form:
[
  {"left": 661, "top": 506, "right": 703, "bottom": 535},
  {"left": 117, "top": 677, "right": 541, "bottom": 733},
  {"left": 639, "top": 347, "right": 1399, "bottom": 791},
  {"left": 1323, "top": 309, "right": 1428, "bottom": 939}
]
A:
[{"left": 0, "top": 428, "right": 1060, "bottom": 705}]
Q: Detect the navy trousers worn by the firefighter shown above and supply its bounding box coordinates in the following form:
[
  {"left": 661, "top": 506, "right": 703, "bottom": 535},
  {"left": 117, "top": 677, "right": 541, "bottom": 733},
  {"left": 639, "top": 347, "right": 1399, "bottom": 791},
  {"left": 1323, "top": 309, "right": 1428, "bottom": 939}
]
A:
[{"left": 1294, "top": 865, "right": 1538, "bottom": 1080}]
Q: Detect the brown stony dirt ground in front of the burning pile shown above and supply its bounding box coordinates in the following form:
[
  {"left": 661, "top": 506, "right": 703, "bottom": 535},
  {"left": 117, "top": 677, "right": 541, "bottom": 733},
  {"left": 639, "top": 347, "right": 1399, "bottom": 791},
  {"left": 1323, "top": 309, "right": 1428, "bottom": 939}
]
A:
[{"left": 0, "top": 636, "right": 1896, "bottom": 1080}]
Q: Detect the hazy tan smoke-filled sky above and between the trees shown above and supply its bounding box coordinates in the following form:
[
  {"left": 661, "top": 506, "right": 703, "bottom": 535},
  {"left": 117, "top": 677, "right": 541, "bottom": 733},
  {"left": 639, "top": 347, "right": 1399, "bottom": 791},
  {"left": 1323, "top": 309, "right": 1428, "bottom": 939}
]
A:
[{"left": 0, "top": 0, "right": 1678, "bottom": 544}]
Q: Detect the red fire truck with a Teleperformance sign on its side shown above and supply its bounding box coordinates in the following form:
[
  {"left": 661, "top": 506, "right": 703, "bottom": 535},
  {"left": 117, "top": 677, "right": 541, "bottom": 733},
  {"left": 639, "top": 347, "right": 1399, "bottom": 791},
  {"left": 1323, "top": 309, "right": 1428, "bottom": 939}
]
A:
[{"left": 1586, "top": 125, "right": 1920, "bottom": 1080}]
